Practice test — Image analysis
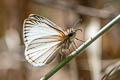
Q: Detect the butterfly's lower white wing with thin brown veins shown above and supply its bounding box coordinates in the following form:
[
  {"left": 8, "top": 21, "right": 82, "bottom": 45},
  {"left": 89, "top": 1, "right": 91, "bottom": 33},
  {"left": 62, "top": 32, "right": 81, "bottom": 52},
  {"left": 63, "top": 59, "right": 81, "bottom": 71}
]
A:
[{"left": 25, "top": 36, "right": 62, "bottom": 66}]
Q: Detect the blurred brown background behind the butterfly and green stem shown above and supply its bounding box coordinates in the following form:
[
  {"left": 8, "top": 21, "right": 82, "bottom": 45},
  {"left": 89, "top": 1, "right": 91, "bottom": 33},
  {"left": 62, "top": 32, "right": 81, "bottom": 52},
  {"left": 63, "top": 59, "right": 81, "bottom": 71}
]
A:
[{"left": 0, "top": 0, "right": 120, "bottom": 80}]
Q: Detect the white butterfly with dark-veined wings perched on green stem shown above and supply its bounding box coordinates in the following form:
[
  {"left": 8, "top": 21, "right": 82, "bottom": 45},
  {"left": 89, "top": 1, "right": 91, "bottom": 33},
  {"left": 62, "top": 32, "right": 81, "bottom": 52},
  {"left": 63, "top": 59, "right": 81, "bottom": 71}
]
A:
[{"left": 23, "top": 14, "right": 81, "bottom": 66}]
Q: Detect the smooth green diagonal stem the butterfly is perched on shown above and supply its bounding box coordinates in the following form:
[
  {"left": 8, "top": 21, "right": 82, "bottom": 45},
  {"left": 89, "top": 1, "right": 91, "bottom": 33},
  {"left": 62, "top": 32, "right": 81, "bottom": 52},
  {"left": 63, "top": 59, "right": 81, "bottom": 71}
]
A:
[{"left": 40, "top": 15, "right": 120, "bottom": 80}]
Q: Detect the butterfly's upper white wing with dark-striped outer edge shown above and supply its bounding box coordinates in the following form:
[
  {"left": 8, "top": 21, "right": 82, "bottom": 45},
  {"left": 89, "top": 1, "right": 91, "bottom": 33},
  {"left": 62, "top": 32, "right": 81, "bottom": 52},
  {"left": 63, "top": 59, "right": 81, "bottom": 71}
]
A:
[{"left": 23, "top": 14, "right": 65, "bottom": 46}]
